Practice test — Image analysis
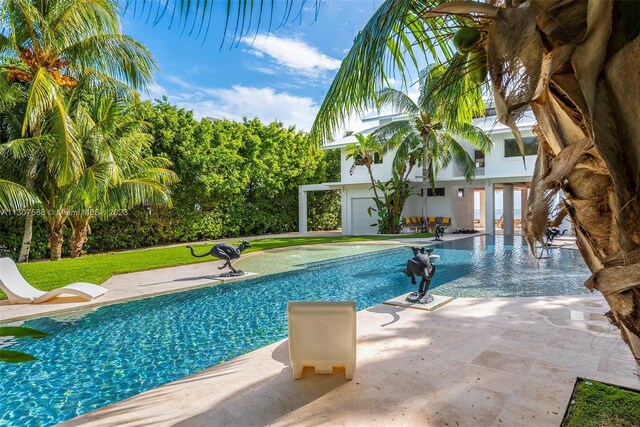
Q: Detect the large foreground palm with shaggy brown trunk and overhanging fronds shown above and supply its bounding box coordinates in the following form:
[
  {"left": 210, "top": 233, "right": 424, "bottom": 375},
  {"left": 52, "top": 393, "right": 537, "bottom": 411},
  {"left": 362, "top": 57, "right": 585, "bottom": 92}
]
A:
[{"left": 311, "top": 0, "right": 640, "bottom": 364}]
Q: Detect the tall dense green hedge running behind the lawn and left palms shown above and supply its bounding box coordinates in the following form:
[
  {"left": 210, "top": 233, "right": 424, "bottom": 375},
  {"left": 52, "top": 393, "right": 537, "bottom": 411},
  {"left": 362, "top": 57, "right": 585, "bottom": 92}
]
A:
[{"left": 0, "top": 99, "right": 340, "bottom": 259}]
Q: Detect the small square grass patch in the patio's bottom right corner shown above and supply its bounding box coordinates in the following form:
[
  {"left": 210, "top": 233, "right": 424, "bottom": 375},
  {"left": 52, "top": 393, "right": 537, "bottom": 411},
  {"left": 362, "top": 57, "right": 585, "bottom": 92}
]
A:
[{"left": 562, "top": 380, "right": 640, "bottom": 427}]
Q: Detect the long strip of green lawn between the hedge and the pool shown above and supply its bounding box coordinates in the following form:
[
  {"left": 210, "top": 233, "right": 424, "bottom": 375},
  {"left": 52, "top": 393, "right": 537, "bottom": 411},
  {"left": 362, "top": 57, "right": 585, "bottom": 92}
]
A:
[{"left": 0, "top": 233, "right": 433, "bottom": 299}]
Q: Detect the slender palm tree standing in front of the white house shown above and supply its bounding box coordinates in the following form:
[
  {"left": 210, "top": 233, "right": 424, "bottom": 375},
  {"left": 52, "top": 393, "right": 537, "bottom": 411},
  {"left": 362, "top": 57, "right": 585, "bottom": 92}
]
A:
[{"left": 374, "top": 68, "right": 493, "bottom": 218}]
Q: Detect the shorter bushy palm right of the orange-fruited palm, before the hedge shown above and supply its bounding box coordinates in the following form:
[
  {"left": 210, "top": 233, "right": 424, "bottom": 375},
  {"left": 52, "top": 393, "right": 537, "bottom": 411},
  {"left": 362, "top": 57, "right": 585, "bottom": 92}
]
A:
[{"left": 68, "top": 90, "right": 178, "bottom": 258}]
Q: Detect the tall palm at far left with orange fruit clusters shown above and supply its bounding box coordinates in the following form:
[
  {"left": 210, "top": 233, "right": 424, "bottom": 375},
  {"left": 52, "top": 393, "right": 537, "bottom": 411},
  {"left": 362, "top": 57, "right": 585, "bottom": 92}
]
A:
[{"left": 0, "top": 0, "right": 156, "bottom": 261}]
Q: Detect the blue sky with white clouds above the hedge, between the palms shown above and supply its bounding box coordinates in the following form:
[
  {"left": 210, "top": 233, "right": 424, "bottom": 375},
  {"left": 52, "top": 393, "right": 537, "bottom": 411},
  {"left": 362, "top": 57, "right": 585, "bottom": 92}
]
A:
[{"left": 122, "top": 0, "right": 381, "bottom": 130}]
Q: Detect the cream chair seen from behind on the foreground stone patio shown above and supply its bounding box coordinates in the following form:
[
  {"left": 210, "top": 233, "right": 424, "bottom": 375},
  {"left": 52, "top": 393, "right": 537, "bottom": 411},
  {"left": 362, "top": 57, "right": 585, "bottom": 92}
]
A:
[{"left": 287, "top": 301, "right": 356, "bottom": 380}]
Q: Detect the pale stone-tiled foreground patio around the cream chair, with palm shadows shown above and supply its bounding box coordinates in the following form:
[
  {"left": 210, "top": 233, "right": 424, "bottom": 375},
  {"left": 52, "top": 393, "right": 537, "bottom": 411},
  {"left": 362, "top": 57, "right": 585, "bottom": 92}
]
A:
[{"left": 58, "top": 295, "right": 640, "bottom": 426}]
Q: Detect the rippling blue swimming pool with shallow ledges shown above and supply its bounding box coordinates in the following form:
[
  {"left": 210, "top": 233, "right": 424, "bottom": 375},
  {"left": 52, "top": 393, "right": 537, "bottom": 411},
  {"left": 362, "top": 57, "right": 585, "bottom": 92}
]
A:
[{"left": 0, "top": 237, "right": 589, "bottom": 426}]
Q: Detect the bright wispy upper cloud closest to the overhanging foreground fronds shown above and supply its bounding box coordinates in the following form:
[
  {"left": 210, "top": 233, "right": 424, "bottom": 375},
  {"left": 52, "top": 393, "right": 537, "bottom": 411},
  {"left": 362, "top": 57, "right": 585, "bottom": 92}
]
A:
[{"left": 242, "top": 34, "right": 340, "bottom": 78}]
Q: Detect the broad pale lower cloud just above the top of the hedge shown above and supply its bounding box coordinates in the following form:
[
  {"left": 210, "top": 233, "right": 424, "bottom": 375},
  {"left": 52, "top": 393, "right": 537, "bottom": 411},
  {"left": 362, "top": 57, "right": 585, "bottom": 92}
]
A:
[{"left": 171, "top": 82, "right": 318, "bottom": 130}]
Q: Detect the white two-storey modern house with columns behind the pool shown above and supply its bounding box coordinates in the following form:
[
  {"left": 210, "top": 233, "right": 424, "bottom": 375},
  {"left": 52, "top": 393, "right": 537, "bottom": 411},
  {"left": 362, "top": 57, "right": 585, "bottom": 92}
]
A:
[{"left": 299, "top": 105, "right": 564, "bottom": 235}]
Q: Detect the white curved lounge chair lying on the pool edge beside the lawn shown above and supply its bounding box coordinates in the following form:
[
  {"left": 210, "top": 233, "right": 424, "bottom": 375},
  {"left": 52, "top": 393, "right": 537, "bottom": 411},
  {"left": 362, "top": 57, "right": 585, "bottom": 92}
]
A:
[{"left": 0, "top": 258, "right": 107, "bottom": 304}]
